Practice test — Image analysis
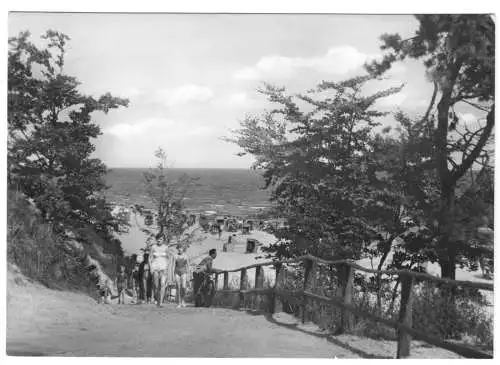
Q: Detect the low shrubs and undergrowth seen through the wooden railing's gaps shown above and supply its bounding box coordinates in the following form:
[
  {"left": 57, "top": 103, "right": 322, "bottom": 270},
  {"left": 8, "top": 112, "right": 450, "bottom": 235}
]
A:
[{"left": 206, "top": 256, "right": 493, "bottom": 349}]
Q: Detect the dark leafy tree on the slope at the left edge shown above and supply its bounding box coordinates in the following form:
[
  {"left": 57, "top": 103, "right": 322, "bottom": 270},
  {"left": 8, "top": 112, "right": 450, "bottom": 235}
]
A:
[{"left": 7, "top": 30, "right": 128, "bottom": 242}]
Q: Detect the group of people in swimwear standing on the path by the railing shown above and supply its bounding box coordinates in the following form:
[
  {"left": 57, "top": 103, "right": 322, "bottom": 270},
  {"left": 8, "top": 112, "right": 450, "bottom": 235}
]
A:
[{"left": 115, "top": 233, "right": 220, "bottom": 308}]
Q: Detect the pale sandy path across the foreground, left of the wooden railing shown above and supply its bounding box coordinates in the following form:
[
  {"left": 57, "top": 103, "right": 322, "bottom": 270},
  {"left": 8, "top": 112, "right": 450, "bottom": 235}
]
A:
[{"left": 7, "top": 271, "right": 458, "bottom": 358}]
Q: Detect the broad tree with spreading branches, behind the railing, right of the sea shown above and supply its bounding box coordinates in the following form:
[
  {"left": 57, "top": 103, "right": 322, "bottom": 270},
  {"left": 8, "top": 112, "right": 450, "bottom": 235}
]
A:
[{"left": 226, "top": 76, "right": 401, "bottom": 259}]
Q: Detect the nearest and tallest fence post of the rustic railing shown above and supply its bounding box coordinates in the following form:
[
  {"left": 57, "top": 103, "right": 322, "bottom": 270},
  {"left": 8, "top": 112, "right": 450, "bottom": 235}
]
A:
[{"left": 397, "top": 275, "right": 413, "bottom": 359}]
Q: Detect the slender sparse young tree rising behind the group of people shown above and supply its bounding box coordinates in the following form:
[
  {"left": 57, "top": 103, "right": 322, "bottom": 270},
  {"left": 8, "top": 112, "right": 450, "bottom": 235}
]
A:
[{"left": 137, "top": 147, "right": 197, "bottom": 243}]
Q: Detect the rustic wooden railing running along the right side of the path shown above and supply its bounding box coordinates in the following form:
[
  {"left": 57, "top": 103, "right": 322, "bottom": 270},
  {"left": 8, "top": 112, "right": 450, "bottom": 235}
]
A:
[{"left": 211, "top": 255, "right": 493, "bottom": 358}]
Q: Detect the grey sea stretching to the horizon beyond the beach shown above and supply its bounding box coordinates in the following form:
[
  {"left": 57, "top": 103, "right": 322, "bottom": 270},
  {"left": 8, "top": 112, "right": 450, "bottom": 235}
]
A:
[{"left": 106, "top": 168, "right": 271, "bottom": 215}]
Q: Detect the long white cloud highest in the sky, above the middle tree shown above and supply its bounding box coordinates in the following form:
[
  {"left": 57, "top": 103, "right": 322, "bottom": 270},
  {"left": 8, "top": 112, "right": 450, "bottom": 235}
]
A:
[{"left": 233, "top": 46, "right": 378, "bottom": 80}]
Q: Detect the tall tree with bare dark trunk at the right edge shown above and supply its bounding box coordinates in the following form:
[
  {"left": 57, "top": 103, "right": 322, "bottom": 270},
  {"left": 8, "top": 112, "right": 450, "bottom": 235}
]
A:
[{"left": 367, "top": 15, "right": 495, "bottom": 278}]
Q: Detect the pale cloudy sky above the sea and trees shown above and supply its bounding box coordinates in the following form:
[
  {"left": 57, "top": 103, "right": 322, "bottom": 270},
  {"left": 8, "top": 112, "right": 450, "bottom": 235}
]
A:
[{"left": 9, "top": 13, "right": 484, "bottom": 168}]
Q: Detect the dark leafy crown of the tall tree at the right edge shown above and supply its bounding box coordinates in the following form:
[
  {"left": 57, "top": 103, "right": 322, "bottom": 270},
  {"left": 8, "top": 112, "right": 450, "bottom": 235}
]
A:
[{"left": 367, "top": 15, "right": 495, "bottom": 190}]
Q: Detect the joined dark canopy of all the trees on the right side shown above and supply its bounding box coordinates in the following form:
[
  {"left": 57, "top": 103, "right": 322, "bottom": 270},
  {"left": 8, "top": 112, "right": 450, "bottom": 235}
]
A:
[{"left": 228, "top": 15, "right": 495, "bottom": 278}]
